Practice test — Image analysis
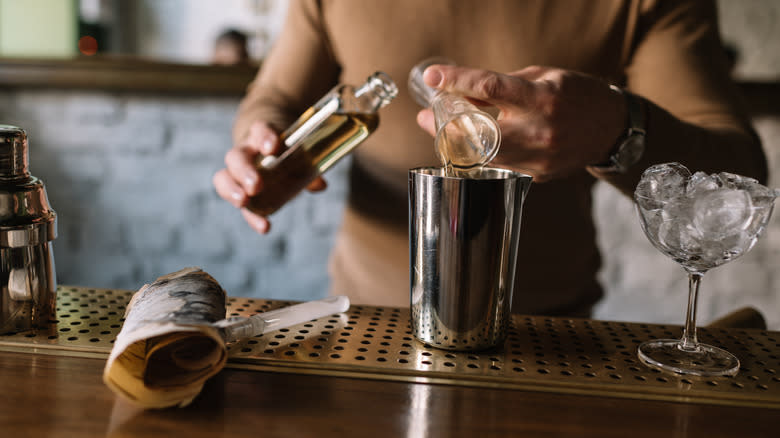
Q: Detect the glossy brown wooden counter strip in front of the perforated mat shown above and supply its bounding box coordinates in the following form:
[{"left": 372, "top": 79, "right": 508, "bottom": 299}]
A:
[{"left": 0, "top": 352, "right": 780, "bottom": 438}]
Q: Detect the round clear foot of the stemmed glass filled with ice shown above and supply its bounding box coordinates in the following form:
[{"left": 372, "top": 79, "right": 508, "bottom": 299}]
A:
[{"left": 637, "top": 339, "right": 739, "bottom": 377}]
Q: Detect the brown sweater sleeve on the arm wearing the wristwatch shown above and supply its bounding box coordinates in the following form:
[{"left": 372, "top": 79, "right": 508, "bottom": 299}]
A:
[{"left": 596, "top": 0, "right": 767, "bottom": 195}]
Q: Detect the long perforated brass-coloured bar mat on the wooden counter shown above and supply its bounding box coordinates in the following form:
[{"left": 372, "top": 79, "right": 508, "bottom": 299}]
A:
[{"left": 0, "top": 287, "right": 780, "bottom": 409}]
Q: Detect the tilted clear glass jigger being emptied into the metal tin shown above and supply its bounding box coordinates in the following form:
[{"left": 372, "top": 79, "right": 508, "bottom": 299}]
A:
[{"left": 409, "top": 57, "right": 501, "bottom": 174}]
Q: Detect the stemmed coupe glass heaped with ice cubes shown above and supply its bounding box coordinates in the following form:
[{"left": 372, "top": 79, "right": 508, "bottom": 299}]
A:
[{"left": 634, "top": 163, "right": 780, "bottom": 376}]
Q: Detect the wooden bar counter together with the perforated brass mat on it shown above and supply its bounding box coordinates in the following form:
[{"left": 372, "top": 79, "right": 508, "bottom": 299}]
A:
[{"left": 0, "top": 288, "right": 780, "bottom": 438}]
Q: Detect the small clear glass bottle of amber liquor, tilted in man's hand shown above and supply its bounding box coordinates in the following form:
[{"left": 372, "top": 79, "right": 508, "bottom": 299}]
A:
[{"left": 247, "top": 72, "right": 398, "bottom": 216}]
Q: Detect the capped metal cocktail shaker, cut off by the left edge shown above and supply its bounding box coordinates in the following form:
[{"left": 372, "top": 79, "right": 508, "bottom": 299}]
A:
[{"left": 0, "top": 125, "right": 57, "bottom": 334}]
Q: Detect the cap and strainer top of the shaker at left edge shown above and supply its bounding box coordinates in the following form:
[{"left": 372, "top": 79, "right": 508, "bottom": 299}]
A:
[{"left": 0, "top": 125, "right": 57, "bottom": 248}]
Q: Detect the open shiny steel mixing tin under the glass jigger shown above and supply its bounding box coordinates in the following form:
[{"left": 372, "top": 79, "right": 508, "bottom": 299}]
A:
[{"left": 409, "top": 168, "right": 531, "bottom": 350}]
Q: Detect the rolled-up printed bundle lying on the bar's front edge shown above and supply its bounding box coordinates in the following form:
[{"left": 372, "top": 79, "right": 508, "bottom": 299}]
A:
[{"left": 103, "top": 268, "right": 227, "bottom": 408}]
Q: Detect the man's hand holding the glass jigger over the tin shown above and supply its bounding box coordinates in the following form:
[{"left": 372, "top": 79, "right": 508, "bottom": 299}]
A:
[{"left": 417, "top": 65, "right": 628, "bottom": 182}]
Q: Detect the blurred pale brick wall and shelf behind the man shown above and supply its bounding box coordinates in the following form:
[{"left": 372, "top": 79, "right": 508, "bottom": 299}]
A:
[{"left": 0, "top": 0, "right": 780, "bottom": 330}]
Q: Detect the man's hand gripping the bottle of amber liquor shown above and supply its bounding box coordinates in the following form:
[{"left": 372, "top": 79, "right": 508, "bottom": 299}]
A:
[{"left": 212, "top": 122, "right": 326, "bottom": 234}]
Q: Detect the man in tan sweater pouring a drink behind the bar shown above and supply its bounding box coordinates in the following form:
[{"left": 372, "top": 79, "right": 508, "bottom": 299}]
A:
[{"left": 214, "top": 0, "right": 767, "bottom": 317}]
